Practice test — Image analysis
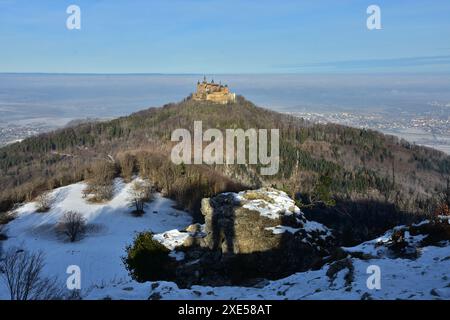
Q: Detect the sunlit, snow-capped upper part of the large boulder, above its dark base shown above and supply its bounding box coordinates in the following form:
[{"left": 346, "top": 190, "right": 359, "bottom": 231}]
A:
[{"left": 201, "top": 188, "right": 332, "bottom": 255}]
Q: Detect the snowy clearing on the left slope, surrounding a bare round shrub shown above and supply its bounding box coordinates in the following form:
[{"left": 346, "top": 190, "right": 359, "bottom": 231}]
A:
[{"left": 0, "top": 179, "right": 192, "bottom": 299}]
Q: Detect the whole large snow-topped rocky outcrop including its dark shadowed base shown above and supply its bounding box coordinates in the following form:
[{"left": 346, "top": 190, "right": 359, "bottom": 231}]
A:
[{"left": 173, "top": 188, "right": 334, "bottom": 286}]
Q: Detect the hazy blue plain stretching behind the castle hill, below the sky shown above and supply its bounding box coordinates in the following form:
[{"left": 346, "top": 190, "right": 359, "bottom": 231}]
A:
[{"left": 0, "top": 73, "right": 450, "bottom": 122}]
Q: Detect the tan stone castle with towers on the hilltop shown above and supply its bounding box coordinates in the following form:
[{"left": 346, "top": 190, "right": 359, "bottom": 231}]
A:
[{"left": 192, "top": 77, "right": 236, "bottom": 104}]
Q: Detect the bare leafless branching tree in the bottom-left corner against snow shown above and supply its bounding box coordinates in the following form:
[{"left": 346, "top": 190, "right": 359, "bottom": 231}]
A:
[{"left": 0, "top": 248, "right": 63, "bottom": 300}]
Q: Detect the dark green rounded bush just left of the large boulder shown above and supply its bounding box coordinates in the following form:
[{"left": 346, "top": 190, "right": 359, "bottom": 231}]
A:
[{"left": 122, "top": 232, "right": 175, "bottom": 282}]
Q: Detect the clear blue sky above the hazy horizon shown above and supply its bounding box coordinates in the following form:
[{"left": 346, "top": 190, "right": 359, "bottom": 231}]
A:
[{"left": 0, "top": 0, "right": 450, "bottom": 74}]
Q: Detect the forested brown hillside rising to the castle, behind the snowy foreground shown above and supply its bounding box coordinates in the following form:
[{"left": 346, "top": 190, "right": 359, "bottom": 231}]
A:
[{"left": 0, "top": 97, "right": 450, "bottom": 242}]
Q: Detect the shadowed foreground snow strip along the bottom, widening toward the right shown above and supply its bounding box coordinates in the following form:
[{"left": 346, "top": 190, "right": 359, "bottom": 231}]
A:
[{"left": 82, "top": 241, "right": 450, "bottom": 300}]
